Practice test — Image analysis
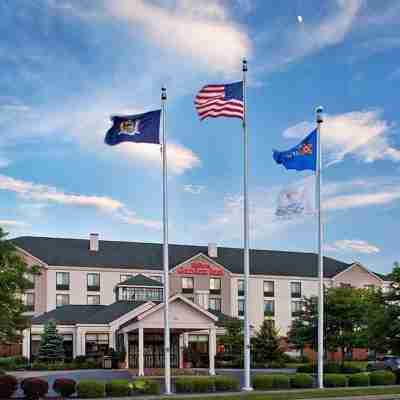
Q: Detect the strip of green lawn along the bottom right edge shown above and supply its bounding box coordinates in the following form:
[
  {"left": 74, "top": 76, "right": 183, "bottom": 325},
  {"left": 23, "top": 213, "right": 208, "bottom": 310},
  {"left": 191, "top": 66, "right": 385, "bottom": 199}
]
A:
[{"left": 164, "top": 386, "right": 400, "bottom": 400}]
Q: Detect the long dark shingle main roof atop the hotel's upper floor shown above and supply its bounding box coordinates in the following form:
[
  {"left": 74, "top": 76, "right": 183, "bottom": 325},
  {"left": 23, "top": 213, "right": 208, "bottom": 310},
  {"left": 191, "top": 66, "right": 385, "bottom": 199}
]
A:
[{"left": 12, "top": 236, "right": 349, "bottom": 278}]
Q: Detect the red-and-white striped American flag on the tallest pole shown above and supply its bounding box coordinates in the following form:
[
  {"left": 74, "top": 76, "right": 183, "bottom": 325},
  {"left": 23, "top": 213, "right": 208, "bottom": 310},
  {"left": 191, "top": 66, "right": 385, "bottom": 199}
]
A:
[{"left": 194, "top": 82, "right": 244, "bottom": 120}]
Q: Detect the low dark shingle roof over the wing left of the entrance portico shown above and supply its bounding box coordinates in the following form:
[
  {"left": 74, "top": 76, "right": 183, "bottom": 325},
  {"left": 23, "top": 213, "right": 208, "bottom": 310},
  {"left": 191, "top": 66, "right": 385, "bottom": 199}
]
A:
[{"left": 32, "top": 301, "right": 146, "bottom": 325}]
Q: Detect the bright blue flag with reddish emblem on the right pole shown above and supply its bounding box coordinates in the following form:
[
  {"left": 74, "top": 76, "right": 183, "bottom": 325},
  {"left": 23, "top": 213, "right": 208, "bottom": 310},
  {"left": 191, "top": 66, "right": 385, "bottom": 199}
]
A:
[{"left": 273, "top": 129, "right": 317, "bottom": 171}]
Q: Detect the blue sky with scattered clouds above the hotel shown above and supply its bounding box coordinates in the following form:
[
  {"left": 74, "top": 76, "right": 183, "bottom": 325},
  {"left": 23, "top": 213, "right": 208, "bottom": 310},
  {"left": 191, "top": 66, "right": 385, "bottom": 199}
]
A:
[{"left": 0, "top": 0, "right": 400, "bottom": 273}]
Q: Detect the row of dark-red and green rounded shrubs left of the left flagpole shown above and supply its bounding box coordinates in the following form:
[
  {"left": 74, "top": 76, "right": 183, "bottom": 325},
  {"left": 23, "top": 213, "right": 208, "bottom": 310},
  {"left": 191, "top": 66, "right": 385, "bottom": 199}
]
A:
[{"left": 0, "top": 375, "right": 160, "bottom": 400}]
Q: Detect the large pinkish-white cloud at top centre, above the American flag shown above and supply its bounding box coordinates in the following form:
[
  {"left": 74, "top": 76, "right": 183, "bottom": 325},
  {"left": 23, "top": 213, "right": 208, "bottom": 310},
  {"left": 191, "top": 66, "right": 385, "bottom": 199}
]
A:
[{"left": 106, "top": 0, "right": 251, "bottom": 73}]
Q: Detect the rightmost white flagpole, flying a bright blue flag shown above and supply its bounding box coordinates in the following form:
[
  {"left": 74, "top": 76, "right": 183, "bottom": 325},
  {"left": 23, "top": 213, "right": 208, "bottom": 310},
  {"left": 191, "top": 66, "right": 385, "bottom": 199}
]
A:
[{"left": 316, "top": 107, "right": 324, "bottom": 389}]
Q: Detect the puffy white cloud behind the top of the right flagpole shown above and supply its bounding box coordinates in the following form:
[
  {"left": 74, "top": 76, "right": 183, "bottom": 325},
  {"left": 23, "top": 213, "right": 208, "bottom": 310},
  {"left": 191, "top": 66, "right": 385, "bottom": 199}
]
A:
[{"left": 283, "top": 111, "right": 400, "bottom": 165}]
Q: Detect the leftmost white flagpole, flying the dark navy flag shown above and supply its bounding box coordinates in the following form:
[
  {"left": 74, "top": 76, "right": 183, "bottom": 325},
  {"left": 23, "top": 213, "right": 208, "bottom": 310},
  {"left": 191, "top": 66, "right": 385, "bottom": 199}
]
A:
[{"left": 161, "top": 87, "right": 171, "bottom": 394}]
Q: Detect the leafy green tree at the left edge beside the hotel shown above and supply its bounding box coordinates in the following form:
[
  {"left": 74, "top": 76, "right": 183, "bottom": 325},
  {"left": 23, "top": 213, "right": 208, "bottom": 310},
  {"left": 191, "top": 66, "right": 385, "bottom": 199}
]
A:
[{"left": 0, "top": 228, "right": 38, "bottom": 343}]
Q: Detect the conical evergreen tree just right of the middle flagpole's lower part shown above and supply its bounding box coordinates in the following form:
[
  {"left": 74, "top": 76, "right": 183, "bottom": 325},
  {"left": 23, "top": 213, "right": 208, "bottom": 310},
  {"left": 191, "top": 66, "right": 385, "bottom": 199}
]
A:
[{"left": 252, "top": 319, "right": 283, "bottom": 362}]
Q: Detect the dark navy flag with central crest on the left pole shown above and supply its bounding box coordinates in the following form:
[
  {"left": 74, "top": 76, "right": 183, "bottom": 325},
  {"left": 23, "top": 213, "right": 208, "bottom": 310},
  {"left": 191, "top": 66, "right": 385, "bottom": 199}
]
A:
[{"left": 104, "top": 110, "right": 161, "bottom": 146}]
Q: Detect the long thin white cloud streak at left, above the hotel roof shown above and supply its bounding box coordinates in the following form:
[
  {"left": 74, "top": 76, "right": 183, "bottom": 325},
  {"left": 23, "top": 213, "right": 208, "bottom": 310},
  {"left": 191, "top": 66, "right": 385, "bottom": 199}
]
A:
[{"left": 0, "top": 175, "right": 160, "bottom": 229}]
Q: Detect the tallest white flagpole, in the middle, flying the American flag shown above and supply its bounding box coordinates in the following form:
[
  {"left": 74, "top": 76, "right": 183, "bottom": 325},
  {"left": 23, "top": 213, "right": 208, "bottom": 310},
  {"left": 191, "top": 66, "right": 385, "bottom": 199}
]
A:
[{"left": 242, "top": 60, "right": 252, "bottom": 391}]
